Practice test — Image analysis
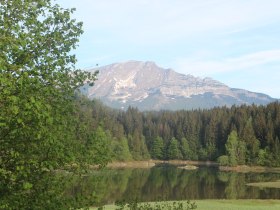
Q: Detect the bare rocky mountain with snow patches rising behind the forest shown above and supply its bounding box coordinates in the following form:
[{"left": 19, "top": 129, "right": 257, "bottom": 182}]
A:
[{"left": 81, "top": 61, "right": 276, "bottom": 110}]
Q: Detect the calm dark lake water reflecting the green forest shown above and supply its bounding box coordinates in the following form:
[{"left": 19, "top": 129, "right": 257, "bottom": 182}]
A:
[{"left": 75, "top": 165, "right": 280, "bottom": 204}]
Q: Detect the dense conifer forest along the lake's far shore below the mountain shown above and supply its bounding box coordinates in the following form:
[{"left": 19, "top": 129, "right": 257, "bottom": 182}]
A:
[{"left": 79, "top": 97, "right": 280, "bottom": 166}]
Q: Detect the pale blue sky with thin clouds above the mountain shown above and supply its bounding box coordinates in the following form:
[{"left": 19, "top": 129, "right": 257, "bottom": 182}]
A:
[{"left": 55, "top": 0, "right": 280, "bottom": 98}]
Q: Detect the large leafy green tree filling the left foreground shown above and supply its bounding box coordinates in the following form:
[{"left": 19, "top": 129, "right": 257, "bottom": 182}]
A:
[{"left": 0, "top": 0, "right": 108, "bottom": 209}]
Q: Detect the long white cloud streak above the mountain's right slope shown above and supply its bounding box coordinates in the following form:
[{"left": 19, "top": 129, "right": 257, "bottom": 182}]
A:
[{"left": 175, "top": 50, "right": 280, "bottom": 76}]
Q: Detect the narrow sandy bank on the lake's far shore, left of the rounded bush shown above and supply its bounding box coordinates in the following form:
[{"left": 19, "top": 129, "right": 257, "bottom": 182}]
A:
[{"left": 107, "top": 159, "right": 219, "bottom": 168}]
